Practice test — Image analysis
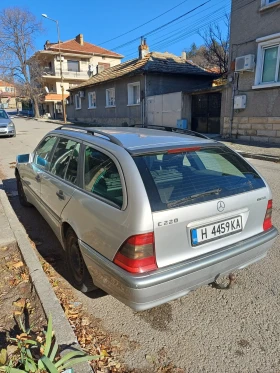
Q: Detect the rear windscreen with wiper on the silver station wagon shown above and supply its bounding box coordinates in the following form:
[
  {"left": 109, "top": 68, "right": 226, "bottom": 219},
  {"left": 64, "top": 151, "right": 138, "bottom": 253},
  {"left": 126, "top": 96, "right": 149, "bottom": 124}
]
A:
[{"left": 134, "top": 146, "right": 265, "bottom": 211}]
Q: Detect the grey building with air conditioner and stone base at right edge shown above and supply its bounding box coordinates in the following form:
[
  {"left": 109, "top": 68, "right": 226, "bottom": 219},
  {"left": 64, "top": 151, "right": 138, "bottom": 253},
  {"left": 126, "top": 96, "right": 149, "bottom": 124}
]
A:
[{"left": 222, "top": 0, "right": 280, "bottom": 143}]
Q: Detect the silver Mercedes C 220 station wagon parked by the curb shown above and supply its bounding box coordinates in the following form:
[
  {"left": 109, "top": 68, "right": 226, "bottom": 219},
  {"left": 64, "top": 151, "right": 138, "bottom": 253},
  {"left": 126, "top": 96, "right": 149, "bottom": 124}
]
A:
[{"left": 16, "top": 126, "right": 278, "bottom": 311}]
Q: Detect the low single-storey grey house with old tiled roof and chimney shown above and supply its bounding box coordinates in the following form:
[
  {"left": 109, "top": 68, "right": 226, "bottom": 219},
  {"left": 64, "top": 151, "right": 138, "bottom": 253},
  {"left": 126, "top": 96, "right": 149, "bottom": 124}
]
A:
[{"left": 67, "top": 45, "right": 216, "bottom": 126}]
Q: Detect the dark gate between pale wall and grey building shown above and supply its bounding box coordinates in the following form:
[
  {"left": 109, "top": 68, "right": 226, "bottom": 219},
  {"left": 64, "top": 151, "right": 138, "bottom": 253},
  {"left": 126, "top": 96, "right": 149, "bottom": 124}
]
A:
[{"left": 192, "top": 92, "right": 222, "bottom": 133}]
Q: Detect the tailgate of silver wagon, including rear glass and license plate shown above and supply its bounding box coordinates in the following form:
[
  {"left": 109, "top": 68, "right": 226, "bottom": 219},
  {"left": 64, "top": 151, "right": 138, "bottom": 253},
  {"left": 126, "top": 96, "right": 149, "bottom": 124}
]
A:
[{"left": 135, "top": 146, "right": 271, "bottom": 267}]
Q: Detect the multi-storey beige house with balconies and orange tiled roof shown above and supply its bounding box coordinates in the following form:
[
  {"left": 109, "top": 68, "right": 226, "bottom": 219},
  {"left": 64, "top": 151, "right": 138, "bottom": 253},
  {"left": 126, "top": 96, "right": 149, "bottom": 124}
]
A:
[{"left": 33, "top": 34, "right": 123, "bottom": 118}]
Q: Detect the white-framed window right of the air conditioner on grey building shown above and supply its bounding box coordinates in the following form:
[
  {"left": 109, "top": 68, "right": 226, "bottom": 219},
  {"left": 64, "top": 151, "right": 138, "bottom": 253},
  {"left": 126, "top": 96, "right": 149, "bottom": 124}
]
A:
[{"left": 253, "top": 36, "right": 280, "bottom": 88}]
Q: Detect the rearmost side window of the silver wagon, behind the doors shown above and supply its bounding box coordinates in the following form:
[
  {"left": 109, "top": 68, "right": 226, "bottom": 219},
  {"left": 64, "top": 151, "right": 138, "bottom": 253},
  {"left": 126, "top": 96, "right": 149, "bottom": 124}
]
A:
[{"left": 84, "top": 146, "right": 123, "bottom": 207}]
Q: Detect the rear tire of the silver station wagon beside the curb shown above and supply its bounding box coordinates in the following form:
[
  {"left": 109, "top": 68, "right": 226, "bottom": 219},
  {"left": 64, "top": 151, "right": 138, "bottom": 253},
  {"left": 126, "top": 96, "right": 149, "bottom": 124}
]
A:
[{"left": 65, "top": 228, "right": 96, "bottom": 293}]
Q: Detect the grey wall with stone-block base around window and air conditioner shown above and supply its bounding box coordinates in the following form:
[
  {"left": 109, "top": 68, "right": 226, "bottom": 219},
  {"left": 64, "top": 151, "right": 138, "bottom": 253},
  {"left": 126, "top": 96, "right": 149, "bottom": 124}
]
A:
[{"left": 221, "top": 0, "right": 280, "bottom": 143}]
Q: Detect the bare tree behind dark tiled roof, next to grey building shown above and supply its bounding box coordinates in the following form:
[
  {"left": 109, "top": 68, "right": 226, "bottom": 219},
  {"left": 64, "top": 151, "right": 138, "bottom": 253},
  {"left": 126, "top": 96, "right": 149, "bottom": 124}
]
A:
[{"left": 200, "top": 14, "right": 230, "bottom": 74}]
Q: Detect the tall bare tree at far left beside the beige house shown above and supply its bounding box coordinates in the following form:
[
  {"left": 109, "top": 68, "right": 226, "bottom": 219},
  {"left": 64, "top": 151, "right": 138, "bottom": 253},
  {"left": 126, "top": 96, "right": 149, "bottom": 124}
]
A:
[{"left": 0, "top": 7, "right": 43, "bottom": 117}]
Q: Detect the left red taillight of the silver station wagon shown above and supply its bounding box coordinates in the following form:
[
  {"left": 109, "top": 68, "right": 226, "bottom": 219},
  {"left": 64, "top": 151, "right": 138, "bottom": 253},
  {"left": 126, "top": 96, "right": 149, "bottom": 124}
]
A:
[{"left": 114, "top": 232, "right": 157, "bottom": 273}]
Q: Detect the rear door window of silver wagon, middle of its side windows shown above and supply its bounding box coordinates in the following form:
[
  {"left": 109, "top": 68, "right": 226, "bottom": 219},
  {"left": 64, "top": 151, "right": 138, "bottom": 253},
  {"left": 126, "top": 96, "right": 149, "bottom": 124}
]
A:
[{"left": 49, "top": 138, "right": 77, "bottom": 179}]
